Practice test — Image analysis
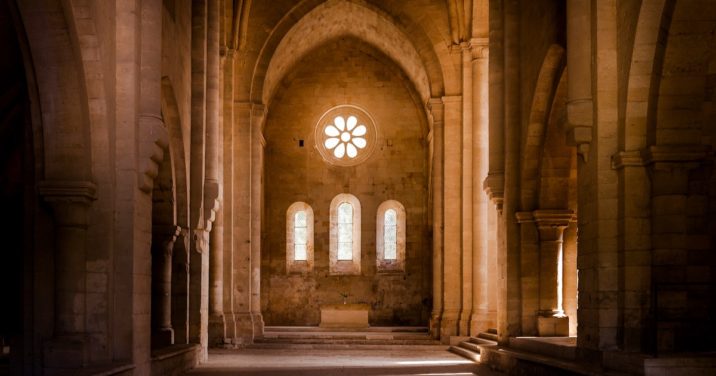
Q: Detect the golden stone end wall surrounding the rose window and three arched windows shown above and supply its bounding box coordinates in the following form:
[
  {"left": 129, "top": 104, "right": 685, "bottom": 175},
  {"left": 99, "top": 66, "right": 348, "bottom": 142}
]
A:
[{"left": 261, "top": 38, "right": 432, "bottom": 325}]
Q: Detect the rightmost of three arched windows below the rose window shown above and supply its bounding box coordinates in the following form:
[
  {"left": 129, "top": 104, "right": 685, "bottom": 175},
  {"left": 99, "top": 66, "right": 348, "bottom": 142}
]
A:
[{"left": 375, "top": 200, "right": 405, "bottom": 272}]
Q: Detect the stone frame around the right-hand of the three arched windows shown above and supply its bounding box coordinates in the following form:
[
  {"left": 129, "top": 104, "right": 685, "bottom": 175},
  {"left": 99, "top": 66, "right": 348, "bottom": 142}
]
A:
[{"left": 375, "top": 200, "right": 406, "bottom": 273}]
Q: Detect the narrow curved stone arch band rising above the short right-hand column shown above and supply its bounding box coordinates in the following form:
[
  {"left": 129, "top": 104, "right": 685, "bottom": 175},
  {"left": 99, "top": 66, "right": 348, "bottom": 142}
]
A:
[{"left": 520, "top": 44, "right": 566, "bottom": 211}]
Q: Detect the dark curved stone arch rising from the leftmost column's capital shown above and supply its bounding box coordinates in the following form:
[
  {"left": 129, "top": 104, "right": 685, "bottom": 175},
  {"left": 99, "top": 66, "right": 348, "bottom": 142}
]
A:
[{"left": 18, "top": 1, "right": 92, "bottom": 181}]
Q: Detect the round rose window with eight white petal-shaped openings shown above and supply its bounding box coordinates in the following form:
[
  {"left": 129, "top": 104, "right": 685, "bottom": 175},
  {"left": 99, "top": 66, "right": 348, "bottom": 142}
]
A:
[{"left": 316, "top": 105, "right": 376, "bottom": 166}]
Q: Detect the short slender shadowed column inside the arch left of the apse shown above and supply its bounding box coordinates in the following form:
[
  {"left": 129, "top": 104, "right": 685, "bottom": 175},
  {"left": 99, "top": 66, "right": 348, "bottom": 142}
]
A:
[{"left": 152, "top": 226, "right": 181, "bottom": 348}]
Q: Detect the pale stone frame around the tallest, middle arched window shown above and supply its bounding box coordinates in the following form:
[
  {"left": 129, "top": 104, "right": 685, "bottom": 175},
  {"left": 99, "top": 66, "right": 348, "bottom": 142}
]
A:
[{"left": 328, "top": 193, "right": 361, "bottom": 275}]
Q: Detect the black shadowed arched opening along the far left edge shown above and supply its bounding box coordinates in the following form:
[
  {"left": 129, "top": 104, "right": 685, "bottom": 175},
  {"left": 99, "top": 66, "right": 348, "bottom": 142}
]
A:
[{"left": 0, "top": 1, "right": 39, "bottom": 374}]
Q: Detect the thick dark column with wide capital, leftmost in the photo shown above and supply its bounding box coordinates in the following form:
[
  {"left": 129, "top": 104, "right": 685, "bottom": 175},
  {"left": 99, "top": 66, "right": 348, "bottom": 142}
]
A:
[{"left": 39, "top": 181, "right": 96, "bottom": 368}]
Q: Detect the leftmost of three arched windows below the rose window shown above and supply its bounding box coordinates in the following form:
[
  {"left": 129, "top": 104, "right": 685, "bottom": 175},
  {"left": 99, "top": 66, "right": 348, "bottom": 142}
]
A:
[{"left": 286, "top": 201, "right": 313, "bottom": 273}]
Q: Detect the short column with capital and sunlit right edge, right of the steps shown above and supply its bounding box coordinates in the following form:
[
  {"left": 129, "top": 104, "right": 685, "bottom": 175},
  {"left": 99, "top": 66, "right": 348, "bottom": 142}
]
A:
[{"left": 532, "top": 210, "right": 574, "bottom": 336}]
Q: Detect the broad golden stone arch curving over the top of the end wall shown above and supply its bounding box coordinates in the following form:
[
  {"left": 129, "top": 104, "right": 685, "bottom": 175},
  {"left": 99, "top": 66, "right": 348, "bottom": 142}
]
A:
[{"left": 251, "top": 0, "right": 443, "bottom": 104}]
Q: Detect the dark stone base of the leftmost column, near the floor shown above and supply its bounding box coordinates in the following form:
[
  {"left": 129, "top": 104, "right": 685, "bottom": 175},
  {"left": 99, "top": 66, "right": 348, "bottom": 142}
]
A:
[{"left": 42, "top": 334, "right": 89, "bottom": 368}]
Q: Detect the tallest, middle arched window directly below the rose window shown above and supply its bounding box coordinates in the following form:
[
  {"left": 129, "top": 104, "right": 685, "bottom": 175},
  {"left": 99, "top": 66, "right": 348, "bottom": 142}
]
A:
[{"left": 329, "top": 193, "right": 361, "bottom": 274}]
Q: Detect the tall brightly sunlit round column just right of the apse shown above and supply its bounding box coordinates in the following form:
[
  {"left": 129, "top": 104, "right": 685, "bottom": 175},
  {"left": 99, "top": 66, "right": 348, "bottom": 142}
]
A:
[{"left": 469, "top": 38, "right": 490, "bottom": 336}]
